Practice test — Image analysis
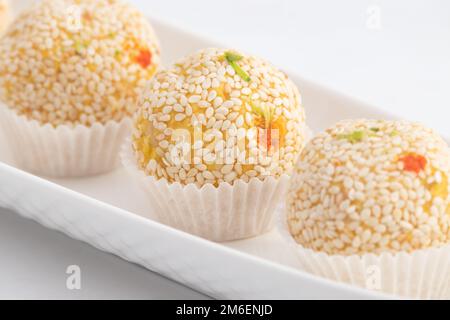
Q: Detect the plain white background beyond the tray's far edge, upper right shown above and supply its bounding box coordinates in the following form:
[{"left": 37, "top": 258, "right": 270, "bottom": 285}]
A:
[{"left": 133, "top": 0, "right": 450, "bottom": 137}]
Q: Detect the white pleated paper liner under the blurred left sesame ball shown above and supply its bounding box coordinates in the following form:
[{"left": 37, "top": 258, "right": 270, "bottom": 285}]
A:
[{"left": 0, "top": 103, "right": 132, "bottom": 178}]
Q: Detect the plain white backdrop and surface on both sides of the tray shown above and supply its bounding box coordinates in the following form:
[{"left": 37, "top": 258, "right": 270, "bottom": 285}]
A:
[{"left": 0, "top": 0, "right": 450, "bottom": 298}]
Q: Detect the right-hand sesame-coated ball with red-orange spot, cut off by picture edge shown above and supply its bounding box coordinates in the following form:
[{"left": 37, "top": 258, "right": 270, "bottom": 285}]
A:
[{"left": 287, "top": 120, "right": 450, "bottom": 255}]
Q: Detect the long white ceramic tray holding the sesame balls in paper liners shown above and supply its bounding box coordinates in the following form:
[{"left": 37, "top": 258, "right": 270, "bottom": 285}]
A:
[{"left": 0, "top": 6, "right": 404, "bottom": 299}]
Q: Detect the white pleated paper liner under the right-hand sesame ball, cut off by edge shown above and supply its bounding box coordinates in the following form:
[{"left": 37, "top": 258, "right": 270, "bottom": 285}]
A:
[{"left": 277, "top": 213, "right": 450, "bottom": 299}]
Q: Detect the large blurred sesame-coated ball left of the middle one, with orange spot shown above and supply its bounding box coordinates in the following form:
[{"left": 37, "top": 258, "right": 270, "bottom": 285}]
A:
[{"left": 0, "top": 0, "right": 160, "bottom": 126}]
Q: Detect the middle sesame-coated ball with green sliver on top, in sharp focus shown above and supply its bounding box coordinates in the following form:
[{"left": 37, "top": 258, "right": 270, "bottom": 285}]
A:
[{"left": 133, "top": 48, "right": 305, "bottom": 187}]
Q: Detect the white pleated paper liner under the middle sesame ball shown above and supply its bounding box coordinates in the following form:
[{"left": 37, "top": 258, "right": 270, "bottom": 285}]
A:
[{"left": 121, "top": 140, "right": 289, "bottom": 242}]
